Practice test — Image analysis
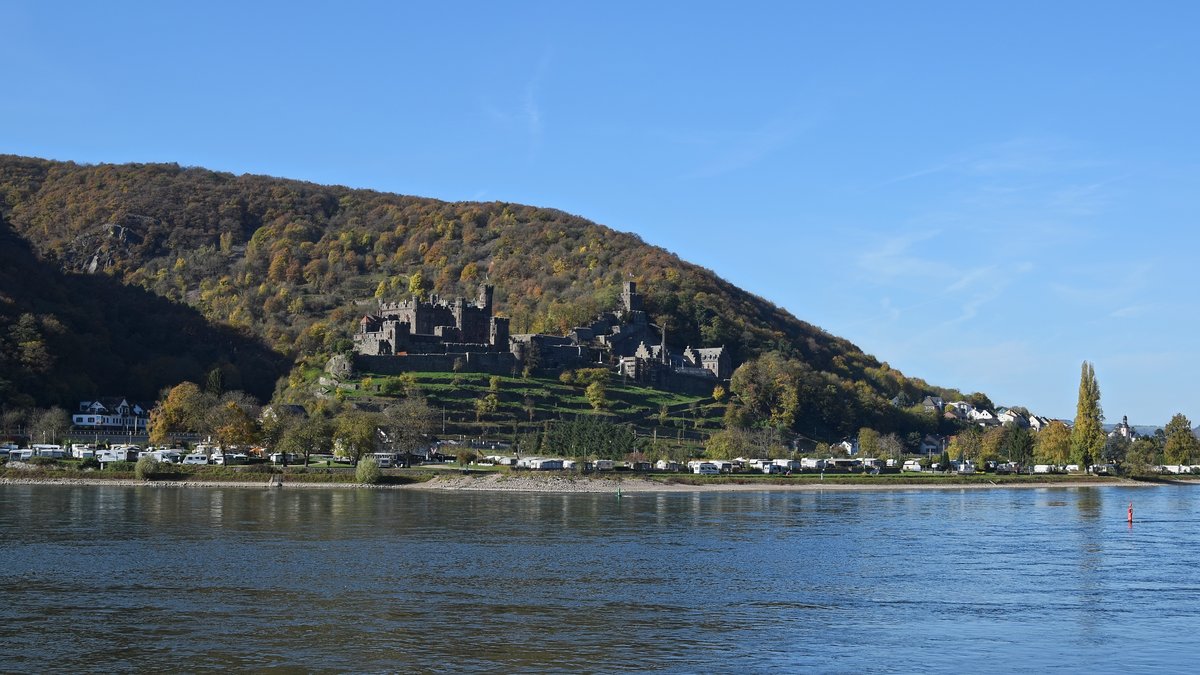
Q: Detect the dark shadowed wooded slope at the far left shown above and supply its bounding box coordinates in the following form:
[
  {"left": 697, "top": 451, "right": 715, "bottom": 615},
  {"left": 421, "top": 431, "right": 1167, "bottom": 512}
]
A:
[{"left": 0, "top": 210, "right": 288, "bottom": 406}]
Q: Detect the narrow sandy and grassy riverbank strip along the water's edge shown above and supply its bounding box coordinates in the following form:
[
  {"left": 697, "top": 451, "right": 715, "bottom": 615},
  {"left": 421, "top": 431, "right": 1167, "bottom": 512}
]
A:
[{"left": 0, "top": 473, "right": 1171, "bottom": 494}]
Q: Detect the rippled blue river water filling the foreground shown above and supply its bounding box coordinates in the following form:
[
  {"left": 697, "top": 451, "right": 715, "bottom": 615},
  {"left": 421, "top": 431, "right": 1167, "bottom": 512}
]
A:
[{"left": 0, "top": 486, "right": 1200, "bottom": 673}]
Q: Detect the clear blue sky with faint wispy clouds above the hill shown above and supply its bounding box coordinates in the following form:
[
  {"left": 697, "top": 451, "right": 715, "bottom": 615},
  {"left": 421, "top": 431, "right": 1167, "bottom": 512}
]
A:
[{"left": 0, "top": 0, "right": 1200, "bottom": 424}]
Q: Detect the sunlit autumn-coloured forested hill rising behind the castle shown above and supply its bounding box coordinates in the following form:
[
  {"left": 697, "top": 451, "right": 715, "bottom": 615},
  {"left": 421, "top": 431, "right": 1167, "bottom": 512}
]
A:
[{"left": 0, "top": 155, "right": 955, "bottom": 415}]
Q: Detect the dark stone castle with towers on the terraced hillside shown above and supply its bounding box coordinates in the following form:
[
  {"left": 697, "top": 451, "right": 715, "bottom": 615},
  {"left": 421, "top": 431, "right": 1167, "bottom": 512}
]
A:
[{"left": 354, "top": 281, "right": 733, "bottom": 394}]
